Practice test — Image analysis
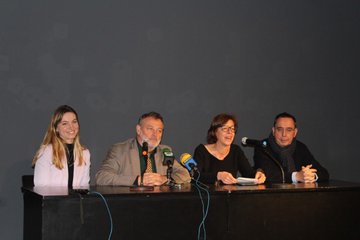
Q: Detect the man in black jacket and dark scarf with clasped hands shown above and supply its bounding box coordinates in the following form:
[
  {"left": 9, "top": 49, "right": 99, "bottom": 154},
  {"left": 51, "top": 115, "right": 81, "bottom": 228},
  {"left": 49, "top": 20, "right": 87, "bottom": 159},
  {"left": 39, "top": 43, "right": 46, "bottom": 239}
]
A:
[{"left": 254, "top": 112, "right": 329, "bottom": 183}]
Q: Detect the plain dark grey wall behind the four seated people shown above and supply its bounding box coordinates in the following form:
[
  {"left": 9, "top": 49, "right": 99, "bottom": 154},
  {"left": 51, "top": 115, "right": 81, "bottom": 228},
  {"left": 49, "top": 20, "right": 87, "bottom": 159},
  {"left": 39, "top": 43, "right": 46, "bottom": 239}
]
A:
[{"left": 0, "top": 0, "right": 360, "bottom": 239}]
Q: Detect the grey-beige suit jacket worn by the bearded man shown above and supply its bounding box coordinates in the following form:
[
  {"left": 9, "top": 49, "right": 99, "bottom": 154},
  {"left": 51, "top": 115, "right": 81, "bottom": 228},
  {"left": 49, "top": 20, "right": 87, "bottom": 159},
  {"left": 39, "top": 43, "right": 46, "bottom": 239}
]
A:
[{"left": 95, "top": 138, "right": 191, "bottom": 186}]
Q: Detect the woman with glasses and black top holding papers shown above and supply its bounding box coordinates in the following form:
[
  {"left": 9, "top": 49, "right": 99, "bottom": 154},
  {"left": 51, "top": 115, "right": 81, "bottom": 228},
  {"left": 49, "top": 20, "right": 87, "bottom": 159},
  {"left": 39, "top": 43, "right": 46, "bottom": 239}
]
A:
[{"left": 194, "top": 113, "right": 266, "bottom": 184}]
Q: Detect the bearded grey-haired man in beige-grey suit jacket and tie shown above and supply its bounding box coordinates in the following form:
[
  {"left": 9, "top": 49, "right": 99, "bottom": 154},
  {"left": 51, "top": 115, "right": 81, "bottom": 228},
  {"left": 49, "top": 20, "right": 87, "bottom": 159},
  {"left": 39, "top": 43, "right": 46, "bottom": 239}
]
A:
[{"left": 95, "top": 112, "right": 191, "bottom": 186}]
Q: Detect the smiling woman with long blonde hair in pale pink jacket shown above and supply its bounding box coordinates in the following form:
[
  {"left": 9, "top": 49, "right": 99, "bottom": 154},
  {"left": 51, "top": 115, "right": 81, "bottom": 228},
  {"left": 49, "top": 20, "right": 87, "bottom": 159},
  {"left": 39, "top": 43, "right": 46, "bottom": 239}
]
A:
[{"left": 32, "top": 105, "right": 90, "bottom": 188}]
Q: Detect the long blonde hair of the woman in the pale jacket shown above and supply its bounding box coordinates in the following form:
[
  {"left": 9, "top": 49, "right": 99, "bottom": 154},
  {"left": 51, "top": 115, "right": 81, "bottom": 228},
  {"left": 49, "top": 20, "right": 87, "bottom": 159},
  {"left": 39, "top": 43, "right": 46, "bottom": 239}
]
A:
[{"left": 32, "top": 105, "right": 85, "bottom": 169}]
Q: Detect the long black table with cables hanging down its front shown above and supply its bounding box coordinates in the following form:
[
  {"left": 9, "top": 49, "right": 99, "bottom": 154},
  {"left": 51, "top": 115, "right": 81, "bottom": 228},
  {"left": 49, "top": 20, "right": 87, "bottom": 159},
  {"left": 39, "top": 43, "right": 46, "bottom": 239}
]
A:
[{"left": 22, "top": 180, "right": 360, "bottom": 240}]
